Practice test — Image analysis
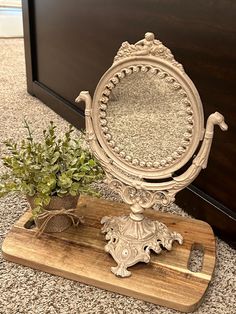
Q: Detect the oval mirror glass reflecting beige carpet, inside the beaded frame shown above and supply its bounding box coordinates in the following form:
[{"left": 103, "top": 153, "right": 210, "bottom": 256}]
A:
[{"left": 106, "top": 71, "right": 192, "bottom": 166}]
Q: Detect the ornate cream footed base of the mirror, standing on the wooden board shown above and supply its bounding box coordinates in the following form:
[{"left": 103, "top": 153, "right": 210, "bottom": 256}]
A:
[{"left": 101, "top": 216, "right": 183, "bottom": 277}]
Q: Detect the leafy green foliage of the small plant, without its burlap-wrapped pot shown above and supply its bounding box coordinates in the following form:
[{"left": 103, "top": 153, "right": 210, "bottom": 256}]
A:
[{"left": 0, "top": 121, "right": 103, "bottom": 216}]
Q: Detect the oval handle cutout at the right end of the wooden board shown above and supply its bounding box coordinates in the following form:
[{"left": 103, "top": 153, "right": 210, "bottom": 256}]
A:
[{"left": 188, "top": 243, "right": 204, "bottom": 273}]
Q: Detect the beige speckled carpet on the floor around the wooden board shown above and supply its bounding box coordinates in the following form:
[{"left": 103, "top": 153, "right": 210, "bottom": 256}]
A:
[{"left": 0, "top": 39, "right": 236, "bottom": 314}]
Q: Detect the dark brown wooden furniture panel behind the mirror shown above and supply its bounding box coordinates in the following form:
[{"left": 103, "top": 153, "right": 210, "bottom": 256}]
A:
[{"left": 23, "top": 0, "right": 236, "bottom": 243}]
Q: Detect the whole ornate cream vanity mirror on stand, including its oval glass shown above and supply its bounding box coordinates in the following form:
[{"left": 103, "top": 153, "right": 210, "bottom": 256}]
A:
[{"left": 76, "top": 33, "right": 227, "bottom": 277}]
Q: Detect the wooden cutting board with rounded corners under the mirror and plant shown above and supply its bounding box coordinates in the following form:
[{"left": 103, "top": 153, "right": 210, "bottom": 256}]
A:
[{"left": 2, "top": 197, "right": 215, "bottom": 312}]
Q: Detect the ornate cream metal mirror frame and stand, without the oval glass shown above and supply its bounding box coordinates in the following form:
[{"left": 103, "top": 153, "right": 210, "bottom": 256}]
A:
[{"left": 76, "top": 33, "right": 227, "bottom": 277}]
